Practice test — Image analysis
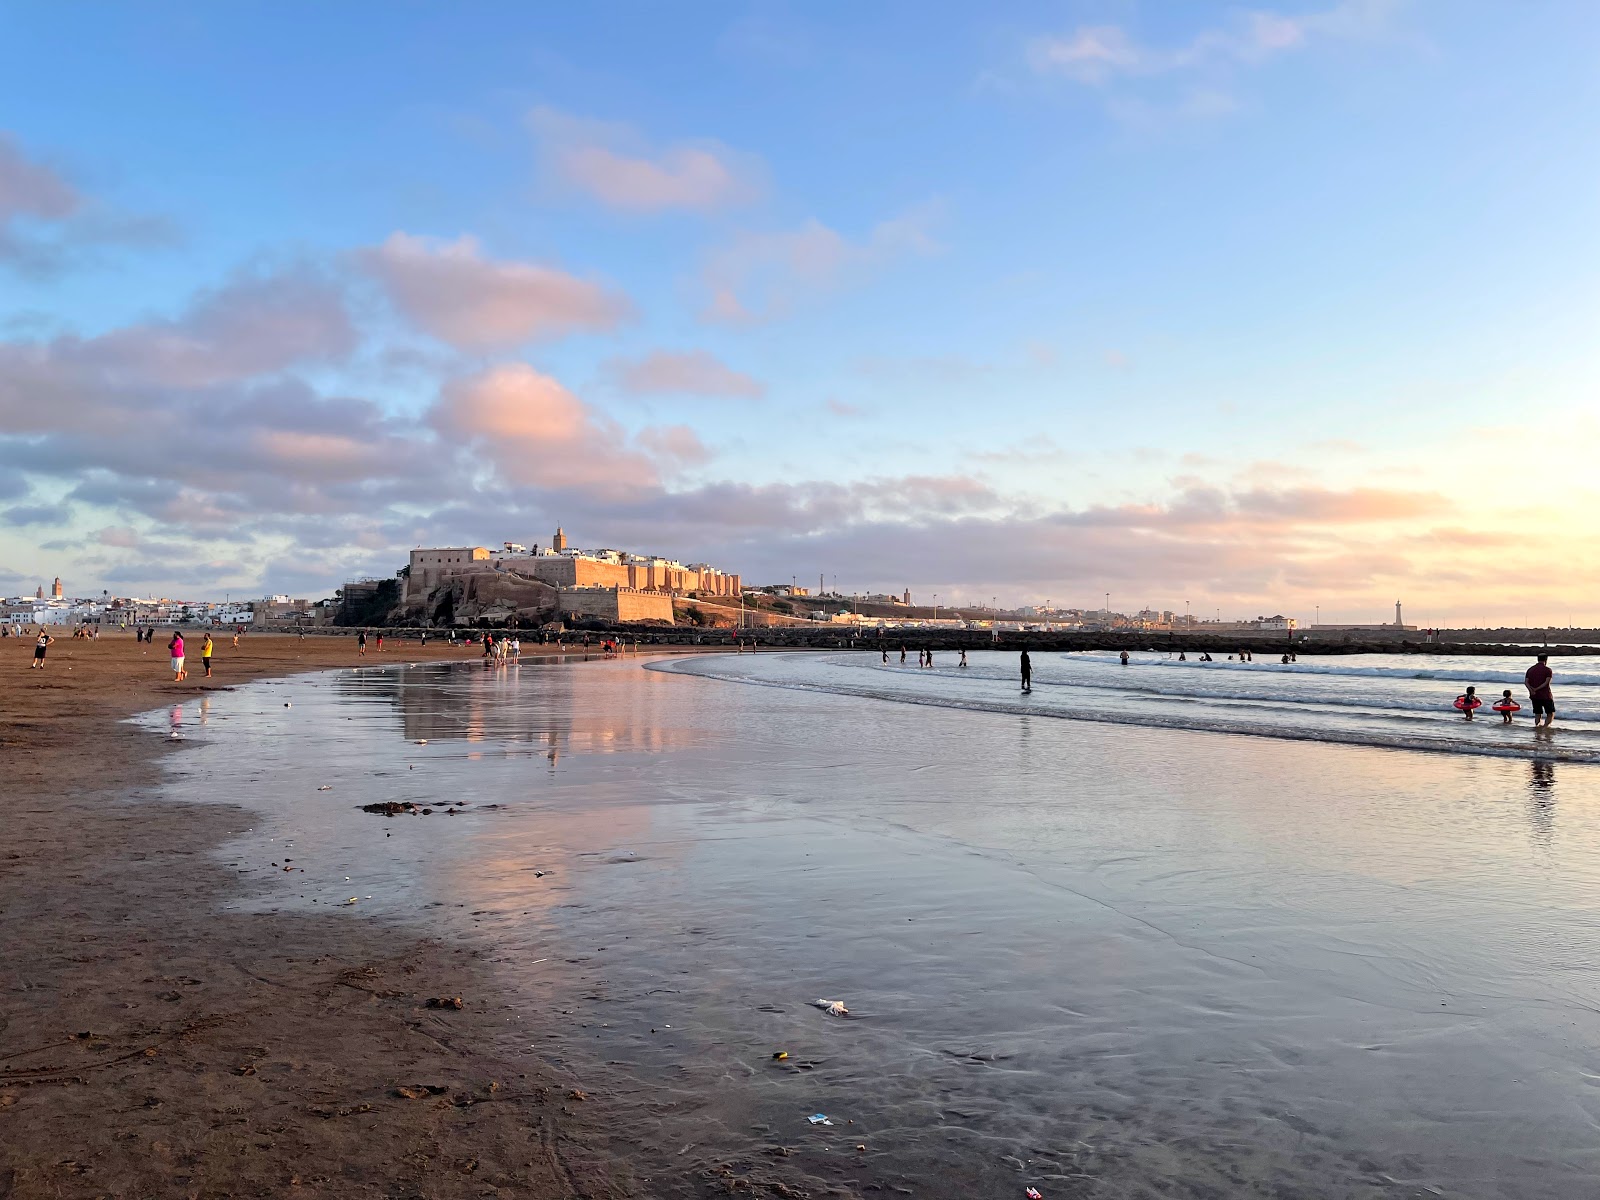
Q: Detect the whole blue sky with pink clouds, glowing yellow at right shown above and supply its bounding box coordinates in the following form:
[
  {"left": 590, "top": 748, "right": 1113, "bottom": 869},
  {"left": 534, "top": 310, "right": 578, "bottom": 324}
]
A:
[{"left": 0, "top": 0, "right": 1600, "bottom": 626}]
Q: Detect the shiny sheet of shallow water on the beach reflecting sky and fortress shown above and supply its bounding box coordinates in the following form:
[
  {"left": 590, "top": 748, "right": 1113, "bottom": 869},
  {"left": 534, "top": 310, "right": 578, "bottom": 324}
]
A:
[{"left": 144, "top": 656, "right": 1600, "bottom": 1197}]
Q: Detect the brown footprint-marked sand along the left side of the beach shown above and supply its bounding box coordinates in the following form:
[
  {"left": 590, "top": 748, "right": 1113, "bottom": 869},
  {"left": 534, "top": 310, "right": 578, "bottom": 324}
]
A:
[{"left": 0, "top": 634, "right": 637, "bottom": 1200}]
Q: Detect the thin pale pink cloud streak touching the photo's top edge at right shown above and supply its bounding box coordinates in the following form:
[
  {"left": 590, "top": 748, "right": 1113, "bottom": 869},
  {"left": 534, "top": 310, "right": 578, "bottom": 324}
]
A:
[{"left": 1027, "top": 0, "right": 1397, "bottom": 83}]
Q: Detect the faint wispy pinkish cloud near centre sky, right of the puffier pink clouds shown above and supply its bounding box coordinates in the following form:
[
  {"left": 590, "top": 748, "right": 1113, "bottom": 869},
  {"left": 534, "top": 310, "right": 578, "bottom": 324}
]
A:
[{"left": 701, "top": 205, "right": 941, "bottom": 323}]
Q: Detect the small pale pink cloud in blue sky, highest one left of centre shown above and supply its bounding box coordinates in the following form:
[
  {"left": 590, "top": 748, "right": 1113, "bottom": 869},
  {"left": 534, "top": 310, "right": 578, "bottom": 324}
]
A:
[{"left": 528, "top": 107, "right": 762, "bottom": 213}]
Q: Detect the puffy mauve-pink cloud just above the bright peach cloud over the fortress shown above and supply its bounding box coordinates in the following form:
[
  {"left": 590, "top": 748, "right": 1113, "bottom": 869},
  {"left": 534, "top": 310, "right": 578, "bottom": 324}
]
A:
[{"left": 355, "top": 232, "right": 632, "bottom": 350}]
